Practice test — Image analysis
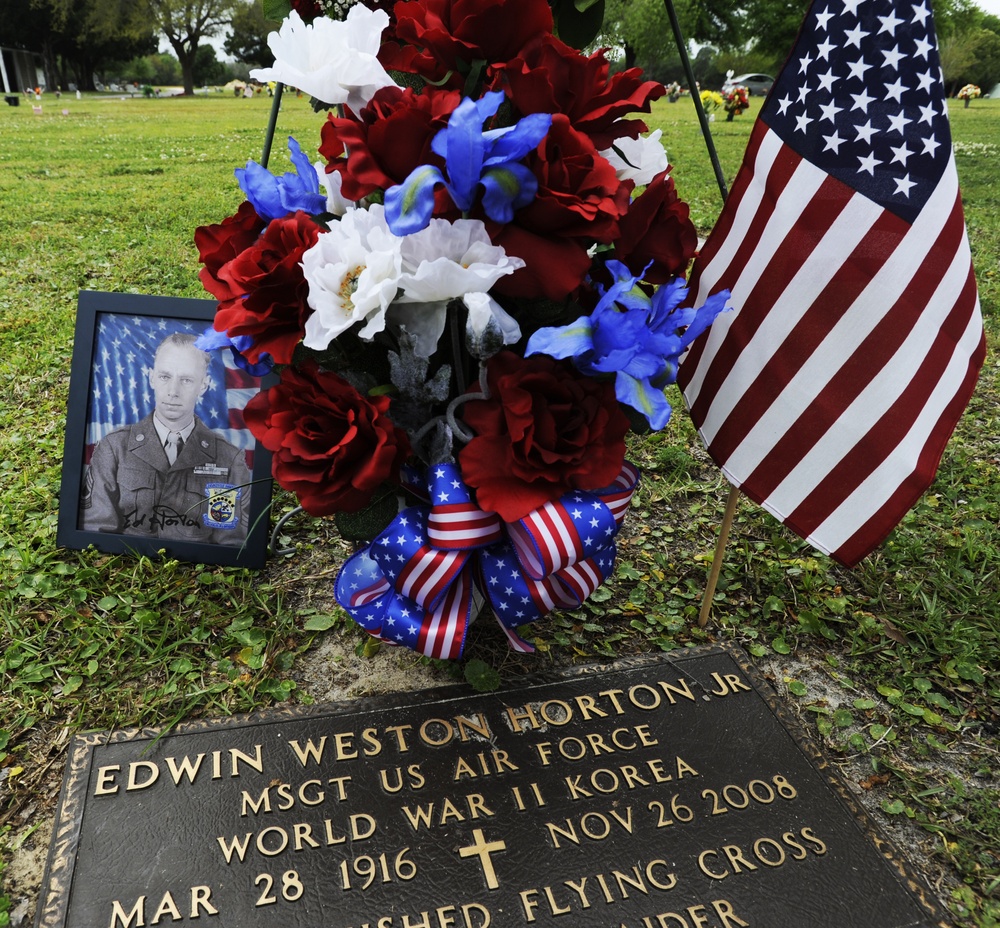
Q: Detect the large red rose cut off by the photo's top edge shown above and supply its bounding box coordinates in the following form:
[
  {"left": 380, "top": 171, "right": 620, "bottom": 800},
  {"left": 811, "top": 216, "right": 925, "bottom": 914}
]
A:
[{"left": 388, "top": 0, "right": 552, "bottom": 89}]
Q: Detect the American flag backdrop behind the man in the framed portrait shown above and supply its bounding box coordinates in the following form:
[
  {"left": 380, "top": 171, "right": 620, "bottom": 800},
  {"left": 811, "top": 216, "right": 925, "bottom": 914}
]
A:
[{"left": 85, "top": 313, "right": 260, "bottom": 470}]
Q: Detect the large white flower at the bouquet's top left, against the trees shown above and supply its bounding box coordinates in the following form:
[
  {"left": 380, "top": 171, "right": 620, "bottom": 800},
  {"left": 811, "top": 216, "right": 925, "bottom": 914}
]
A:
[{"left": 250, "top": 3, "right": 393, "bottom": 113}]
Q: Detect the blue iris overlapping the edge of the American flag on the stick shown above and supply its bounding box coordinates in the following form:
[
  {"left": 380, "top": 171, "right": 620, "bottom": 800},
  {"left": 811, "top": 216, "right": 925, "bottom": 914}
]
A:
[{"left": 524, "top": 261, "right": 731, "bottom": 429}]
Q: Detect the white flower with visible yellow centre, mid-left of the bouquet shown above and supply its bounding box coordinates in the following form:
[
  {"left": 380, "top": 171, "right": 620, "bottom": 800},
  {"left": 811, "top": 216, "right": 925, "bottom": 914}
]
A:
[{"left": 302, "top": 205, "right": 402, "bottom": 351}]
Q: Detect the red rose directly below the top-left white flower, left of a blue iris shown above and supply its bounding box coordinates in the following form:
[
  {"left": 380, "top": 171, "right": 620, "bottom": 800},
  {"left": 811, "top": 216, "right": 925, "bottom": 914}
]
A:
[{"left": 319, "top": 87, "right": 461, "bottom": 200}]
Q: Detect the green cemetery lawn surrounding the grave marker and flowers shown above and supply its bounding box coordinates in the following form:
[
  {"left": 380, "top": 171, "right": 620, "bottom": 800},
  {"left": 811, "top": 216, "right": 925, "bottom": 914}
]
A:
[{"left": 0, "top": 94, "right": 1000, "bottom": 928}]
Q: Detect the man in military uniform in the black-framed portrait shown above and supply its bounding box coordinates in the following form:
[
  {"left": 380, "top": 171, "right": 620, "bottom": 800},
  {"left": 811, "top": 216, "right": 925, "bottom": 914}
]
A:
[{"left": 80, "top": 333, "right": 250, "bottom": 545}]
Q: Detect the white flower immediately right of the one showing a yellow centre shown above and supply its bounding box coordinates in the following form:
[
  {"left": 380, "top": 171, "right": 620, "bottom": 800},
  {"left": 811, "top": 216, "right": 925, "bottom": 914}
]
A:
[{"left": 391, "top": 219, "right": 524, "bottom": 357}]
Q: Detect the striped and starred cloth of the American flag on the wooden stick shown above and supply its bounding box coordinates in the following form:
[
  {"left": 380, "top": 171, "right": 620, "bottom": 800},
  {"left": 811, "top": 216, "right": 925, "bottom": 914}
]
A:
[{"left": 678, "top": 0, "right": 986, "bottom": 566}]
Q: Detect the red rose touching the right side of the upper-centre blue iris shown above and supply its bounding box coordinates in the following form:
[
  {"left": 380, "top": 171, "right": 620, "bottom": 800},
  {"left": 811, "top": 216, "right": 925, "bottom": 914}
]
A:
[{"left": 487, "top": 113, "right": 633, "bottom": 300}]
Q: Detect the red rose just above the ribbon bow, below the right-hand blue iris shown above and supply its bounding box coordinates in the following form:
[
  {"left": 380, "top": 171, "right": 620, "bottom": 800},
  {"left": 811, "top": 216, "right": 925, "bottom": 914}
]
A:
[{"left": 458, "top": 351, "right": 629, "bottom": 522}]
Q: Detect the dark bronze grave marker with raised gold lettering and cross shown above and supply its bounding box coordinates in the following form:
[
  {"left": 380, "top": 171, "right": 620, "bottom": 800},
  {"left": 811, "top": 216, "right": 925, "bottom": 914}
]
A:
[{"left": 37, "top": 647, "right": 939, "bottom": 928}]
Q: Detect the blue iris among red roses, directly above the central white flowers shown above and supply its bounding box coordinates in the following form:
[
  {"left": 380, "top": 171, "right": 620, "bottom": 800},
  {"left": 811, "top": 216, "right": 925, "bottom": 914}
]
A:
[{"left": 385, "top": 91, "right": 552, "bottom": 235}]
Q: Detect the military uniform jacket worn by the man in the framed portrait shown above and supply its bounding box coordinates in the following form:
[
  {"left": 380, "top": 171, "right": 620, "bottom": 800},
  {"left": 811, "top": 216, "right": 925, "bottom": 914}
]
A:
[{"left": 80, "top": 413, "right": 250, "bottom": 545}]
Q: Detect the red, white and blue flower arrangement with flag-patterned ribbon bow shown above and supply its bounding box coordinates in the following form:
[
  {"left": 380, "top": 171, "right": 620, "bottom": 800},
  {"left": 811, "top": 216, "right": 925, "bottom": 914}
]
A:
[{"left": 195, "top": 0, "right": 728, "bottom": 658}]
